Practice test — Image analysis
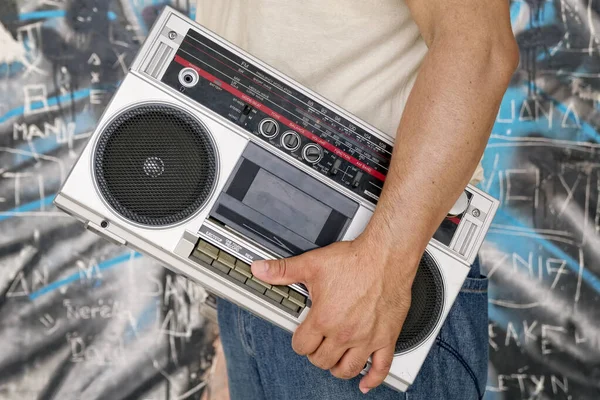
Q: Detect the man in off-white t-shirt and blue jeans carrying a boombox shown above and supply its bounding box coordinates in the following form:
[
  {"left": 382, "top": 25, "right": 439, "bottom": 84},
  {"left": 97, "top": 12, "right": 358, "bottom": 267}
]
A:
[{"left": 197, "top": 0, "right": 518, "bottom": 400}]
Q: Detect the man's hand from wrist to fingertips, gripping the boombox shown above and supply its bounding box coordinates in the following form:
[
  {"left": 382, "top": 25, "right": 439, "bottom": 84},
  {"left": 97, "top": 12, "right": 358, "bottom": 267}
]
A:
[{"left": 252, "top": 234, "right": 421, "bottom": 393}]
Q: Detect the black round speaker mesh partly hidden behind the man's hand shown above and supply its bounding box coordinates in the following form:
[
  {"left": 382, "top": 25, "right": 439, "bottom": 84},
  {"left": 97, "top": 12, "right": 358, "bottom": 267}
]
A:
[{"left": 396, "top": 252, "right": 444, "bottom": 353}]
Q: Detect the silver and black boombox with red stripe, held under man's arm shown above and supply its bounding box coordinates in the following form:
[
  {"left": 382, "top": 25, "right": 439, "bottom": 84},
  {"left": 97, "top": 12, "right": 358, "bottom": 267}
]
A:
[{"left": 54, "top": 7, "right": 498, "bottom": 390}]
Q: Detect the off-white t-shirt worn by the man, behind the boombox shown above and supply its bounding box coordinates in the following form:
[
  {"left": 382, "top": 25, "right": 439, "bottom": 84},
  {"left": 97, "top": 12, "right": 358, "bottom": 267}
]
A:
[{"left": 196, "top": 0, "right": 483, "bottom": 183}]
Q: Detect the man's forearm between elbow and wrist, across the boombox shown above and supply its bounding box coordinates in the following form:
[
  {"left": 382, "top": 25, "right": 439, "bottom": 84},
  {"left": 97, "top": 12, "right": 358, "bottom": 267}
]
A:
[{"left": 365, "top": 36, "right": 518, "bottom": 264}]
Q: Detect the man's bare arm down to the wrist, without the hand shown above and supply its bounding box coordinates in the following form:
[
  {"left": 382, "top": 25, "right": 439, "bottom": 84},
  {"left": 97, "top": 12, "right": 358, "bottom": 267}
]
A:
[{"left": 369, "top": 0, "right": 518, "bottom": 256}]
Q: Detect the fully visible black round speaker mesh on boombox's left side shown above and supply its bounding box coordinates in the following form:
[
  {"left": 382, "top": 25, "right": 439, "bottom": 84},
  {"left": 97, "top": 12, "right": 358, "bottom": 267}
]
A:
[{"left": 94, "top": 104, "right": 217, "bottom": 226}]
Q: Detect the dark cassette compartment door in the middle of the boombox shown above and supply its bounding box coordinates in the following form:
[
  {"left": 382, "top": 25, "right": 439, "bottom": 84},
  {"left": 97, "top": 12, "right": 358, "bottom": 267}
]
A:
[{"left": 211, "top": 143, "right": 358, "bottom": 256}]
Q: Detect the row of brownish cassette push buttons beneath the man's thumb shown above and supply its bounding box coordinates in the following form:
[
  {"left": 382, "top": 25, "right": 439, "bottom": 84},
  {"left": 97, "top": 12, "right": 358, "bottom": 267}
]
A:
[{"left": 192, "top": 240, "right": 306, "bottom": 313}]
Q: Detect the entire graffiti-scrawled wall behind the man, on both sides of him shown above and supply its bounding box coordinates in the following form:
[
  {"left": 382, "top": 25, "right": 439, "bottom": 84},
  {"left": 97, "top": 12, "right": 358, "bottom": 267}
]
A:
[{"left": 0, "top": 0, "right": 600, "bottom": 400}]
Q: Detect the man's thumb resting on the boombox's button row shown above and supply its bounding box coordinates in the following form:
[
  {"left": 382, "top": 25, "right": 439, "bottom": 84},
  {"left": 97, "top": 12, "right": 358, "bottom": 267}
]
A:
[{"left": 252, "top": 256, "right": 308, "bottom": 285}]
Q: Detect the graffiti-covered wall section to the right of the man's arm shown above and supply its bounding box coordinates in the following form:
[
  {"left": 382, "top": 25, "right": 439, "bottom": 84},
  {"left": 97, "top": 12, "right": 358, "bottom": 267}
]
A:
[{"left": 481, "top": 0, "right": 600, "bottom": 400}]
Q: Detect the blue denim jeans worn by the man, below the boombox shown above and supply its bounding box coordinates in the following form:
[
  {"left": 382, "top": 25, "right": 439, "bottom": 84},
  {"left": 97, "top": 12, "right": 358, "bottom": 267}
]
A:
[{"left": 218, "top": 261, "right": 488, "bottom": 400}]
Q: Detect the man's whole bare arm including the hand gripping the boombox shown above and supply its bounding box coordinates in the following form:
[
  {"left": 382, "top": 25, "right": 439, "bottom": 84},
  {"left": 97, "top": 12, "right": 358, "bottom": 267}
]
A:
[{"left": 252, "top": 0, "right": 518, "bottom": 392}]
